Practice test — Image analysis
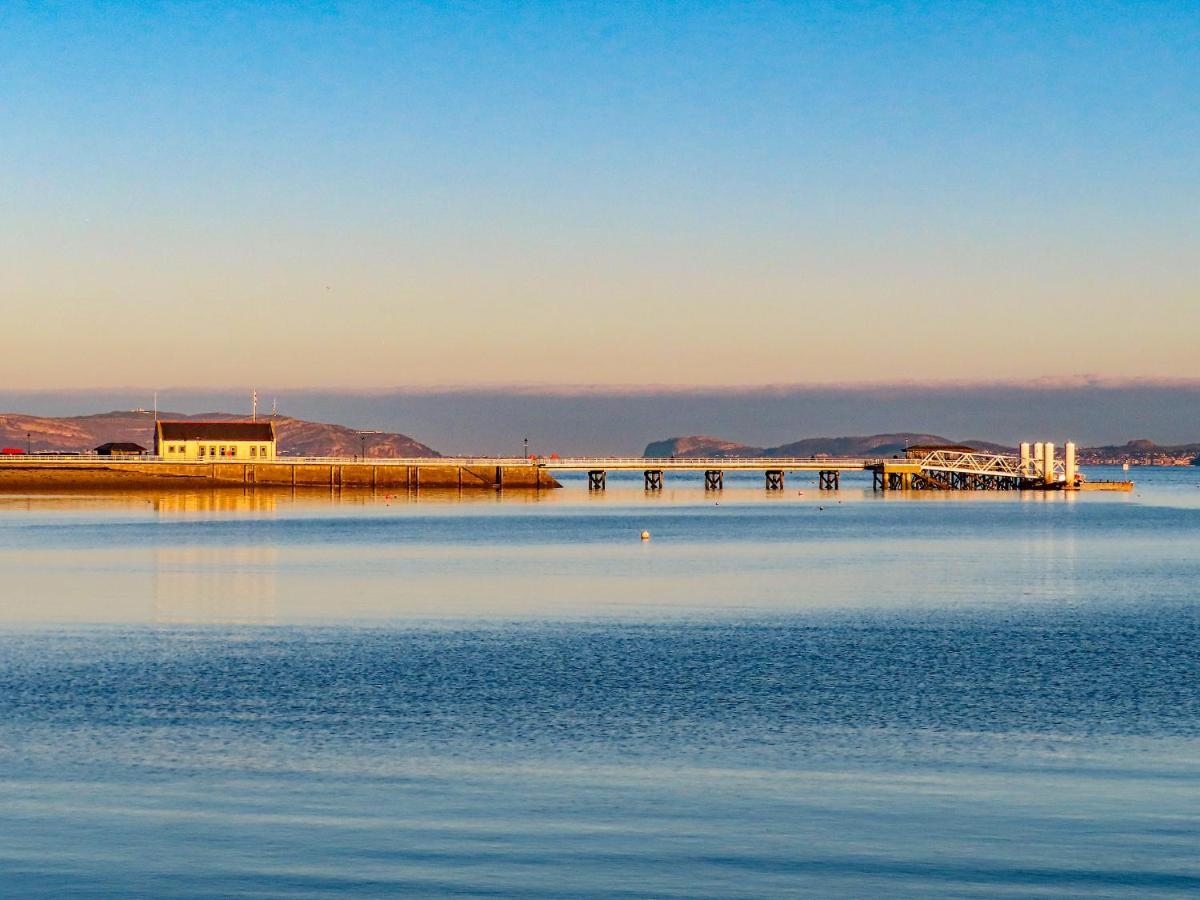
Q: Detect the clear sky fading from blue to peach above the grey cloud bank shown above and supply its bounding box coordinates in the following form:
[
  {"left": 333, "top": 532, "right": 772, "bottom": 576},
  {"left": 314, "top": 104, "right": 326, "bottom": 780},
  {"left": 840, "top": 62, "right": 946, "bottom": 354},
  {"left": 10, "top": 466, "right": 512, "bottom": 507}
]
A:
[{"left": 0, "top": 0, "right": 1200, "bottom": 392}]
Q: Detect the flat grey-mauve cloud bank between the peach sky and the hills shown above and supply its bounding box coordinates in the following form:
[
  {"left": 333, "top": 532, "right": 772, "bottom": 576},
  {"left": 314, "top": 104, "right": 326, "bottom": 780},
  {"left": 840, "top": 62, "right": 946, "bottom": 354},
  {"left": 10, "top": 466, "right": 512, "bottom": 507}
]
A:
[{"left": 0, "top": 382, "right": 1200, "bottom": 455}]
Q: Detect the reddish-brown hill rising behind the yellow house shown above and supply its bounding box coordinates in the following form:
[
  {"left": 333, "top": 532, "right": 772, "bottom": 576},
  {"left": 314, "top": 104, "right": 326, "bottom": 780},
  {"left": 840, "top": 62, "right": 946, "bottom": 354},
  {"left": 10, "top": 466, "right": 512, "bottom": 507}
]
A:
[{"left": 0, "top": 409, "right": 440, "bottom": 458}]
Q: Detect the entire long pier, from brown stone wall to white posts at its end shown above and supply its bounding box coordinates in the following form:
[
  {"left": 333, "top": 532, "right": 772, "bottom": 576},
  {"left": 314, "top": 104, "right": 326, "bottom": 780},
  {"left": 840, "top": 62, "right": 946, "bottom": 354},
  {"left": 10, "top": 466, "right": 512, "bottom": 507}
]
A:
[{"left": 0, "top": 442, "right": 1132, "bottom": 492}]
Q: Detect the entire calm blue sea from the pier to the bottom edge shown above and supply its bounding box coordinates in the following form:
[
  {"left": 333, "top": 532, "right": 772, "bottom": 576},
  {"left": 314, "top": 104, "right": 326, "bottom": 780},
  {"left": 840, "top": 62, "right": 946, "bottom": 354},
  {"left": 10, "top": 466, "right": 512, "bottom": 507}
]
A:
[{"left": 0, "top": 469, "right": 1200, "bottom": 898}]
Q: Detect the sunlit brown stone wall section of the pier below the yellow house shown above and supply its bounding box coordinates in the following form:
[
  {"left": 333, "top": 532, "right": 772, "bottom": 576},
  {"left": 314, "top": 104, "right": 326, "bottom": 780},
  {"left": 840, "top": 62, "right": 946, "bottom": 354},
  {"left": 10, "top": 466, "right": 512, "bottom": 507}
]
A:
[{"left": 0, "top": 457, "right": 562, "bottom": 491}]
